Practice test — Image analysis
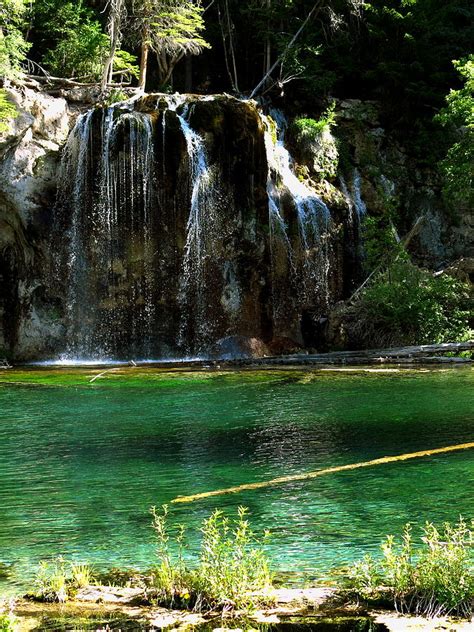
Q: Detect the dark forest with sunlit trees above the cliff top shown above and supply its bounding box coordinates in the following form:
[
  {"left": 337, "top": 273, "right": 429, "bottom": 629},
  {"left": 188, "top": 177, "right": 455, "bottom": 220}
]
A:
[{"left": 0, "top": 0, "right": 474, "bottom": 175}]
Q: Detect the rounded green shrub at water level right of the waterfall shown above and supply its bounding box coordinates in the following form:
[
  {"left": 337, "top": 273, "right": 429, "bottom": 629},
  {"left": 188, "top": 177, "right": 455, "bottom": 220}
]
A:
[{"left": 352, "top": 258, "right": 472, "bottom": 347}]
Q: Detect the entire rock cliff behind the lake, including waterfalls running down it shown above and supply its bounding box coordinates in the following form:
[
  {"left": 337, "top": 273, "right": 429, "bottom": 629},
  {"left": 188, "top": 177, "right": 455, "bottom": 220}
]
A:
[{"left": 0, "top": 89, "right": 472, "bottom": 360}]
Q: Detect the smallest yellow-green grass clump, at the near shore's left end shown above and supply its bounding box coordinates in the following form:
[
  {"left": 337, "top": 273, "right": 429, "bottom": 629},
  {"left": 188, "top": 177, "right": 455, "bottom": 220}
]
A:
[{"left": 34, "top": 557, "right": 94, "bottom": 603}]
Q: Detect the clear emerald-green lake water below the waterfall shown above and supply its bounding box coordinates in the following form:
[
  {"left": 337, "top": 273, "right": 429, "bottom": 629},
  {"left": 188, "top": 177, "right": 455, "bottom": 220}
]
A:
[{"left": 0, "top": 368, "right": 474, "bottom": 590}]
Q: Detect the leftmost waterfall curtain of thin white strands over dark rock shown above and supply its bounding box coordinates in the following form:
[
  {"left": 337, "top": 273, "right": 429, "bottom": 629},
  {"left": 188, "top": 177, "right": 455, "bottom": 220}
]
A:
[{"left": 59, "top": 106, "right": 155, "bottom": 359}]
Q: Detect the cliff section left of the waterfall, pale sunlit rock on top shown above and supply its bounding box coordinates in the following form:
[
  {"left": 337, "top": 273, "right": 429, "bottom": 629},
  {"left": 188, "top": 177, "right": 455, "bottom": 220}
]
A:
[{"left": 0, "top": 88, "right": 72, "bottom": 358}]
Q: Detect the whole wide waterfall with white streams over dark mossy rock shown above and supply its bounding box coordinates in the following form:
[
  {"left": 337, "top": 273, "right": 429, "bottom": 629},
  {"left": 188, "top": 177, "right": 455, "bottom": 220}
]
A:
[{"left": 53, "top": 95, "right": 342, "bottom": 360}]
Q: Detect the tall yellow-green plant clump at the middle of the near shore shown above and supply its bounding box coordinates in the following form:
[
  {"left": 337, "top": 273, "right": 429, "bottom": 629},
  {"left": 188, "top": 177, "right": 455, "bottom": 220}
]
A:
[{"left": 152, "top": 506, "right": 272, "bottom": 611}]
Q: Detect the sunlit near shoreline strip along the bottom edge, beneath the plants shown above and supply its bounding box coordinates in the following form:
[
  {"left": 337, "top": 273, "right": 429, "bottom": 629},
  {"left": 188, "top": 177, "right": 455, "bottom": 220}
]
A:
[{"left": 7, "top": 586, "right": 474, "bottom": 632}]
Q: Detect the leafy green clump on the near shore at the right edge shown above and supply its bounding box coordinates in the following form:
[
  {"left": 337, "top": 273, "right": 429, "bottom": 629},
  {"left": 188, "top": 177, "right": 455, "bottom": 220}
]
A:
[{"left": 348, "top": 518, "right": 474, "bottom": 617}]
